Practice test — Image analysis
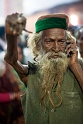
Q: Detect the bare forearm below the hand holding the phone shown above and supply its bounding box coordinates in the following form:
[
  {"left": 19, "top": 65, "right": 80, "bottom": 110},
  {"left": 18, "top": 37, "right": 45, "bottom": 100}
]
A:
[{"left": 71, "top": 63, "right": 83, "bottom": 90}]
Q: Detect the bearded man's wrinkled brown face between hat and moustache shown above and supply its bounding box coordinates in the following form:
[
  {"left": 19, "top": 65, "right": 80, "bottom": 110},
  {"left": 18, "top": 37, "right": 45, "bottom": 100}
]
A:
[{"left": 42, "top": 28, "right": 66, "bottom": 58}]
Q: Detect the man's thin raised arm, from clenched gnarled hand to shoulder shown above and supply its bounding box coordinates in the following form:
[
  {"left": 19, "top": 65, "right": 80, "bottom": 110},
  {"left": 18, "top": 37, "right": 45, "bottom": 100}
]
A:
[{"left": 4, "top": 13, "right": 28, "bottom": 84}]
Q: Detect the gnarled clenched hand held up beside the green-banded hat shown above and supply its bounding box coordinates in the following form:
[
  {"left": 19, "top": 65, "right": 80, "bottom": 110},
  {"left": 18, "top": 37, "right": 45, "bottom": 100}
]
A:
[{"left": 5, "top": 13, "right": 26, "bottom": 36}]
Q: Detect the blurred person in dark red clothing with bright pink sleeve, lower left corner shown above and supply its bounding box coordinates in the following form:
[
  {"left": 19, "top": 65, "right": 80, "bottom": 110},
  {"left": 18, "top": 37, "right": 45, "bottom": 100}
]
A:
[{"left": 0, "top": 62, "right": 25, "bottom": 124}]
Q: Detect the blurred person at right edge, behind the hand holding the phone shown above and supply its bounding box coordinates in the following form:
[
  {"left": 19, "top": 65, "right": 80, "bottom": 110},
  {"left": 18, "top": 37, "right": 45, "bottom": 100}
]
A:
[{"left": 75, "top": 26, "right": 83, "bottom": 58}]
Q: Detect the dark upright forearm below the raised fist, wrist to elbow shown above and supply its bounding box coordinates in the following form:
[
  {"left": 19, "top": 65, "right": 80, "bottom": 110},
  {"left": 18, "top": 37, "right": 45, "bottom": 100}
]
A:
[{"left": 4, "top": 34, "right": 18, "bottom": 64}]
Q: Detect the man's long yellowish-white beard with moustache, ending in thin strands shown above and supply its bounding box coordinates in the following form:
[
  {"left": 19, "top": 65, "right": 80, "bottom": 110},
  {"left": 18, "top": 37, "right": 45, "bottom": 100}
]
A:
[{"left": 39, "top": 52, "right": 68, "bottom": 108}]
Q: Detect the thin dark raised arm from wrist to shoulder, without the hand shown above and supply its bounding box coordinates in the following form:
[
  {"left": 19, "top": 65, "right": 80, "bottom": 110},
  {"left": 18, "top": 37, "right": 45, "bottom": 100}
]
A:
[{"left": 4, "top": 34, "right": 28, "bottom": 83}]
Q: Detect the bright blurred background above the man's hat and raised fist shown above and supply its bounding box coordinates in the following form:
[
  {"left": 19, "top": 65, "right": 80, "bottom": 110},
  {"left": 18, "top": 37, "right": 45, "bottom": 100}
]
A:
[{"left": 0, "top": 0, "right": 83, "bottom": 31}]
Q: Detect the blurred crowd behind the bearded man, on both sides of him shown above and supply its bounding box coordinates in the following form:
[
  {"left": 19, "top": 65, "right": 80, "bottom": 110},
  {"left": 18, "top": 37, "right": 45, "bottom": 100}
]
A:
[{"left": 0, "top": 22, "right": 83, "bottom": 124}]
